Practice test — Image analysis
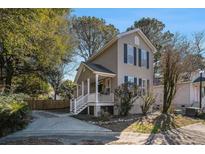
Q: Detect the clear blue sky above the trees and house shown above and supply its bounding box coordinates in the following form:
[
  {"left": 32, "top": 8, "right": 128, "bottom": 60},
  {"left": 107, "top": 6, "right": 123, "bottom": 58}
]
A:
[{"left": 67, "top": 8, "right": 205, "bottom": 80}]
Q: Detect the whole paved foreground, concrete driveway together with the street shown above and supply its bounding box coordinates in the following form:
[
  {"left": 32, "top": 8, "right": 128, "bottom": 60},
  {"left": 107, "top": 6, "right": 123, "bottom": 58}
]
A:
[{"left": 0, "top": 111, "right": 205, "bottom": 145}]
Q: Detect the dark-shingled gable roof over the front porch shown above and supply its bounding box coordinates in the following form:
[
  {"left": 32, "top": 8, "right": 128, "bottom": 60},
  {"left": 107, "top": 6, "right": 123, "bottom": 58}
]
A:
[{"left": 74, "top": 62, "right": 116, "bottom": 82}]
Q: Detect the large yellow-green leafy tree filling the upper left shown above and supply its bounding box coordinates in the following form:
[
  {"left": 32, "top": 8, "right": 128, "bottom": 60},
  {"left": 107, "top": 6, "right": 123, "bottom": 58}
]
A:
[{"left": 0, "top": 9, "right": 72, "bottom": 90}]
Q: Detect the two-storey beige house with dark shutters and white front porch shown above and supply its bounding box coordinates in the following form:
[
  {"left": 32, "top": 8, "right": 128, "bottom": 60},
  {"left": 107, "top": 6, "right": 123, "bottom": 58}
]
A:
[{"left": 70, "top": 29, "right": 156, "bottom": 116}]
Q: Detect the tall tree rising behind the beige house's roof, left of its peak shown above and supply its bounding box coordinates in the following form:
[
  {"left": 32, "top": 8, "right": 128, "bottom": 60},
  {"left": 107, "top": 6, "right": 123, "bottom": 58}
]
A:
[{"left": 72, "top": 16, "right": 118, "bottom": 61}]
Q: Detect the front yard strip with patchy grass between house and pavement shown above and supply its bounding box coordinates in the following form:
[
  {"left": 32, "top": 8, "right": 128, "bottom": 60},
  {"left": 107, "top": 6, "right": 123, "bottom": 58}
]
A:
[{"left": 75, "top": 113, "right": 205, "bottom": 134}]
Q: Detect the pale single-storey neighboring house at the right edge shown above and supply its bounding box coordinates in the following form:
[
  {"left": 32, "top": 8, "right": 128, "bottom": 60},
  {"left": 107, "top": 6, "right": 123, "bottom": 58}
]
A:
[{"left": 153, "top": 71, "right": 205, "bottom": 108}]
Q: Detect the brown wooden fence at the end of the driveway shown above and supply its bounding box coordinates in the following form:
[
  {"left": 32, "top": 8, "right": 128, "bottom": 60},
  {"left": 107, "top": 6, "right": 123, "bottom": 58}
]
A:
[{"left": 27, "top": 100, "right": 70, "bottom": 110}]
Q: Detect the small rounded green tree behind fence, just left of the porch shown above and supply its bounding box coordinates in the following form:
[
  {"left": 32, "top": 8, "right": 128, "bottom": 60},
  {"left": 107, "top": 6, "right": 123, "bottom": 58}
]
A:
[{"left": 60, "top": 80, "right": 76, "bottom": 100}]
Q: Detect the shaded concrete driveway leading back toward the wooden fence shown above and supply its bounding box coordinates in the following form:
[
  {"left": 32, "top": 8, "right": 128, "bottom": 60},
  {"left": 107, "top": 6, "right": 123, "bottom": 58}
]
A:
[{"left": 2, "top": 111, "right": 111, "bottom": 138}]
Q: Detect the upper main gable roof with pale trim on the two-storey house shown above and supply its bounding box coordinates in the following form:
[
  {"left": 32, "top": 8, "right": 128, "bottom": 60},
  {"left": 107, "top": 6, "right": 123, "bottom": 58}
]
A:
[{"left": 87, "top": 28, "right": 157, "bottom": 62}]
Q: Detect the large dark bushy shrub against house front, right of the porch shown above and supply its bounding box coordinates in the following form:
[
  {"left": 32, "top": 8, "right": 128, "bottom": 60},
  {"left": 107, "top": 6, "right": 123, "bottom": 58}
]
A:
[{"left": 115, "top": 83, "right": 139, "bottom": 116}]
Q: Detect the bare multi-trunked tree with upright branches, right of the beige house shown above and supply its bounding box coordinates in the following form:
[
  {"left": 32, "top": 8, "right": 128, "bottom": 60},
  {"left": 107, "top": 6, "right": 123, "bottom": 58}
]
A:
[{"left": 161, "top": 34, "right": 192, "bottom": 113}]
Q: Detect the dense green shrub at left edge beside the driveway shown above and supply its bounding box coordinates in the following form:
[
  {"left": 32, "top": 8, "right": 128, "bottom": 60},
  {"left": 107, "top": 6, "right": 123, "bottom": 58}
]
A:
[{"left": 0, "top": 94, "right": 30, "bottom": 136}]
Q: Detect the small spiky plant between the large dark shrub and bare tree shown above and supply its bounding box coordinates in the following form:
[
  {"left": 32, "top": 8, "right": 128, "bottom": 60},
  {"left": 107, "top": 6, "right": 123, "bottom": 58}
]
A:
[{"left": 140, "top": 94, "right": 155, "bottom": 115}]
